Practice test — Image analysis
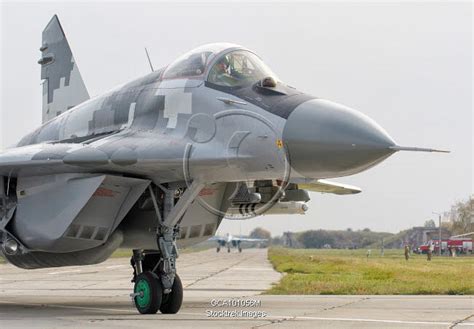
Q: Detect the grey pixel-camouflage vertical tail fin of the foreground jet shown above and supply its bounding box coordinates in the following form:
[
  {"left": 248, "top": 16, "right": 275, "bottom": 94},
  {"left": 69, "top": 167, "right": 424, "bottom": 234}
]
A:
[{"left": 38, "top": 15, "right": 89, "bottom": 123}]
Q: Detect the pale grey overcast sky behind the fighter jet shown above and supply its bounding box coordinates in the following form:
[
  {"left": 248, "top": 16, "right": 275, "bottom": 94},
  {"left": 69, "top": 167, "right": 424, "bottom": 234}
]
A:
[{"left": 0, "top": 1, "right": 473, "bottom": 234}]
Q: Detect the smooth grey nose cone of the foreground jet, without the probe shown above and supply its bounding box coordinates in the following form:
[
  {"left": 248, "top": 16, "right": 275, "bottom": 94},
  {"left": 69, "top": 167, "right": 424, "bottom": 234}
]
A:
[{"left": 283, "top": 99, "right": 395, "bottom": 178}]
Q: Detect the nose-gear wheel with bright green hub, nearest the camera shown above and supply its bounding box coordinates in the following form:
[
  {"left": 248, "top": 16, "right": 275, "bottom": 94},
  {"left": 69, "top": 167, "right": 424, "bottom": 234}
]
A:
[{"left": 133, "top": 272, "right": 163, "bottom": 314}]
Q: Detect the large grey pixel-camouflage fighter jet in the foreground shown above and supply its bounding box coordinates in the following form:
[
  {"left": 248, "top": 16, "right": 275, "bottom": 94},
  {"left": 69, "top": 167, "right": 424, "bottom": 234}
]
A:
[{"left": 0, "top": 16, "right": 446, "bottom": 313}]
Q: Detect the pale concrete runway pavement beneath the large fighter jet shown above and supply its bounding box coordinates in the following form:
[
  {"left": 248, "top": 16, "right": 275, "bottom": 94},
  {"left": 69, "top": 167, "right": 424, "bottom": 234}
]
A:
[{"left": 0, "top": 249, "right": 474, "bottom": 329}]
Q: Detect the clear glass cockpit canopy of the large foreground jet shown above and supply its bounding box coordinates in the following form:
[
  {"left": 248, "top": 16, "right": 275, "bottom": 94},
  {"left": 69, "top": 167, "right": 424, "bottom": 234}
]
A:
[{"left": 163, "top": 43, "right": 278, "bottom": 88}]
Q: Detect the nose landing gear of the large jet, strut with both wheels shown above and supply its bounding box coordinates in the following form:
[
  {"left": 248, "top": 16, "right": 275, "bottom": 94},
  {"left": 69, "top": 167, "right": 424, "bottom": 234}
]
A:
[{"left": 130, "top": 182, "right": 203, "bottom": 314}]
